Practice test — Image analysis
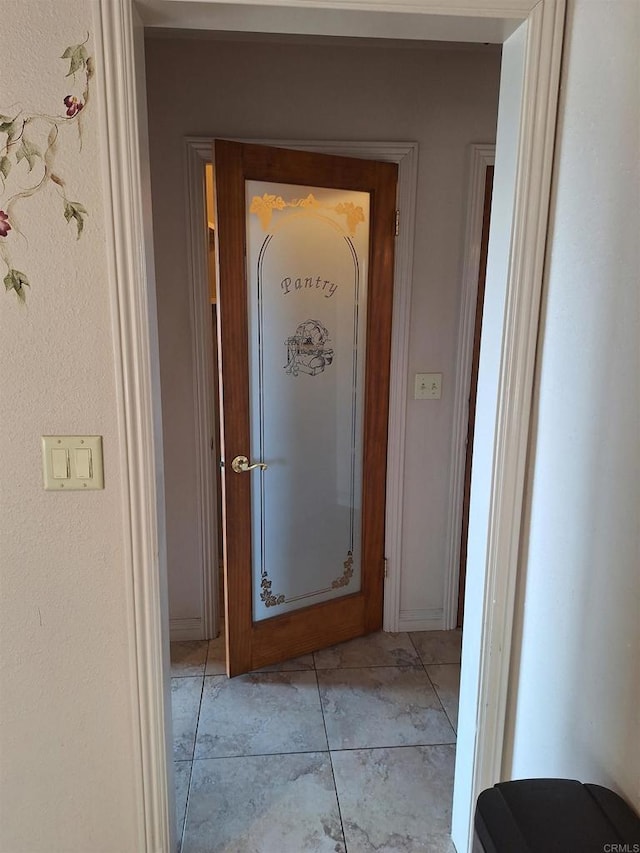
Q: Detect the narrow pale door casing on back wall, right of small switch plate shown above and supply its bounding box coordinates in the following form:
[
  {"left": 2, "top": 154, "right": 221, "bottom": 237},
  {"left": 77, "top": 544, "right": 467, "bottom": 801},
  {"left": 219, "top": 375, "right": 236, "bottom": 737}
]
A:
[{"left": 443, "top": 144, "right": 496, "bottom": 630}]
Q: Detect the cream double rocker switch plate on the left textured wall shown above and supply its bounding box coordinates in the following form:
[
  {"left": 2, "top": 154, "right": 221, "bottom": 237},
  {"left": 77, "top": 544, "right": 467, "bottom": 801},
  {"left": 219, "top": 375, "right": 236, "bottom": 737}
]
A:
[{"left": 42, "top": 435, "right": 104, "bottom": 492}]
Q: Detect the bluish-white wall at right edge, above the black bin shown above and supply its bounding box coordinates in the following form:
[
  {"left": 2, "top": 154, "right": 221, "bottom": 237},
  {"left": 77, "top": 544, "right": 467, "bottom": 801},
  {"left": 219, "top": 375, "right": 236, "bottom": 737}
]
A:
[{"left": 505, "top": 0, "right": 640, "bottom": 807}]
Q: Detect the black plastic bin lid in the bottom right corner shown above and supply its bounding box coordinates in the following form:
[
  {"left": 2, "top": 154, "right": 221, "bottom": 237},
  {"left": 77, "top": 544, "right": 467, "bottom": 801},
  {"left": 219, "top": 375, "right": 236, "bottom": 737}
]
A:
[{"left": 473, "top": 779, "right": 640, "bottom": 853}]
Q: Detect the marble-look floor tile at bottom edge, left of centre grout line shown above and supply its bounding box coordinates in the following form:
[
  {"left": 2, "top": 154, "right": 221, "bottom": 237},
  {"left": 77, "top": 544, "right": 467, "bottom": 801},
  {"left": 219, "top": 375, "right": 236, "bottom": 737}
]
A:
[{"left": 182, "top": 752, "right": 345, "bottom": 853}]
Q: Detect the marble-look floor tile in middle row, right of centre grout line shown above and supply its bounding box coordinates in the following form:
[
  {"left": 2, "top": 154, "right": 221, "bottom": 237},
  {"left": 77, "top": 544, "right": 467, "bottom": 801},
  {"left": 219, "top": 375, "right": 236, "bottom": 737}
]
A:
[{"left": 317, "top": 667, "right": 455, "bottom": 749}]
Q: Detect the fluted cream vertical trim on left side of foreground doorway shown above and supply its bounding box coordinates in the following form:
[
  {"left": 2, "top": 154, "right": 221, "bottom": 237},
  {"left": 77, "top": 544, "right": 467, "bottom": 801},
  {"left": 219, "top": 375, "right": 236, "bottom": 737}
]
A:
[{"left": 95, "top": 0, "right": 170, "bottom": 853}]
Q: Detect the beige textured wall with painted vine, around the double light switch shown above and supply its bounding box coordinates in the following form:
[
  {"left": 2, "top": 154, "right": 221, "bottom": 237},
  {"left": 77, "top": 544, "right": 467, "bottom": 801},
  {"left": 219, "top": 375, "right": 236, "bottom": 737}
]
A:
[{"left": 0, "top": 0, "right": 142, "bottom": 853}]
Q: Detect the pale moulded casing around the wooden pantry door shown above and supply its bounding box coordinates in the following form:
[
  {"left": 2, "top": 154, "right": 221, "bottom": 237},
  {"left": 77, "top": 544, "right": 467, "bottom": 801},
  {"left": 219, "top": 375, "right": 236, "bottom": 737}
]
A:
[{"left": 182, "top": 136, "right": 418, "bottom": 639}]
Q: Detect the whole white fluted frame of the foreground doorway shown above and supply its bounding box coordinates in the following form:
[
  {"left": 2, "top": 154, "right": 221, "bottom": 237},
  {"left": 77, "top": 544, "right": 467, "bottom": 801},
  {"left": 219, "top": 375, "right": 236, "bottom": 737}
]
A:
[{"left": 94, "top": 0, "right": 566, "bottom": 853}]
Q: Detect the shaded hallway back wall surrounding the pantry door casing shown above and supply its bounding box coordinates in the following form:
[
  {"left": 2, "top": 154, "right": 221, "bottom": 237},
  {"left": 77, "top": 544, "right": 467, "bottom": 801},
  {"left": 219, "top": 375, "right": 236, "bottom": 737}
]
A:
[{"left": 147, "top": 33, "right": 500, "bottom": 627}]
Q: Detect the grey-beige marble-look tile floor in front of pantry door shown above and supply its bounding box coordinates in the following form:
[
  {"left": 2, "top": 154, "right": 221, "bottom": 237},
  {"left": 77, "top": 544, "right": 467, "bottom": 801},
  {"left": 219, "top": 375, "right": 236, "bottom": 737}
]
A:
[{"left": 171, "top": 631, "right": 461, "bottom": 853}]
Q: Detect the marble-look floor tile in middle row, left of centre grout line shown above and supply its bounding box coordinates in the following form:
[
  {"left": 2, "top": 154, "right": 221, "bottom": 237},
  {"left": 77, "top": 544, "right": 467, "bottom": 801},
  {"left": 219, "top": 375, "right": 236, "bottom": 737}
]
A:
[{"left": 195, "top": 672, "right": 327, "bottom": 758}]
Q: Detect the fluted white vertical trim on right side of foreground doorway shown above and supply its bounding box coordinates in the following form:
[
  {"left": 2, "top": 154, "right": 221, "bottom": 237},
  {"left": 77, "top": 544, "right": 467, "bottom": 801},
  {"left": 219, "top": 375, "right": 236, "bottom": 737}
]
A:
[{"left": 454, "top": 0, "right": 566, "bottom": 839}]
